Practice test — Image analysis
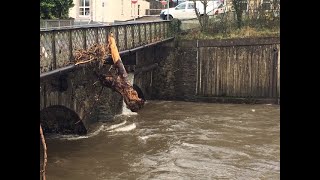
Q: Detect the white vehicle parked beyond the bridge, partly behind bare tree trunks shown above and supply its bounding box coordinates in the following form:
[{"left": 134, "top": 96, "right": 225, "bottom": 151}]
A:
[{"left": 160, "top": 0, "right": 221, "bottom": 20}]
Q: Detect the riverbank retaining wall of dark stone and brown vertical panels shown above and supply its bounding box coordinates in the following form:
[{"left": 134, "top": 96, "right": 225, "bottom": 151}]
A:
[{"left": 151, "top": 38, "right": 280, "bottom": 103}]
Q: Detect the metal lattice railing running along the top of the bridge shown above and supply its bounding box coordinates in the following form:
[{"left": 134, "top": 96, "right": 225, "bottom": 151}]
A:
[{"left": 40, "top": 21, "right": 173, "bottom": 74}]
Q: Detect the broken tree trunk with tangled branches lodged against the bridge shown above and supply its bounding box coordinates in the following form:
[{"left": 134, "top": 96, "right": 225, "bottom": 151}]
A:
[{"left": 74, "top": 33, "right": 145, "bottom": 112}]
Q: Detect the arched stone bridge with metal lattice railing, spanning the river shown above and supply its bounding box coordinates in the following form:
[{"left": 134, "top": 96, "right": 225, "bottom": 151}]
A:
[{"left": 40, "top": 21, "right": 173, "bottom": 134}]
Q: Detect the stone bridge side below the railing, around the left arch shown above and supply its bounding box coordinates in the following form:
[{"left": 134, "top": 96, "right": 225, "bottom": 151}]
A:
[{"left": 40, "top": 65, "right": 122, "bottom": 133}]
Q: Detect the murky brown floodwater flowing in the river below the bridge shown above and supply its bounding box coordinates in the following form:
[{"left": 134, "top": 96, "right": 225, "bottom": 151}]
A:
[{"left": 46, "top": 101, "right": 280, "bottom": 180}]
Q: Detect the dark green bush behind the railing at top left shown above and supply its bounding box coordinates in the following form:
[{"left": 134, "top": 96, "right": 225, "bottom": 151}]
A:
[{"left": 40, "top": 0, "right": 74, "bottom": 19}]
